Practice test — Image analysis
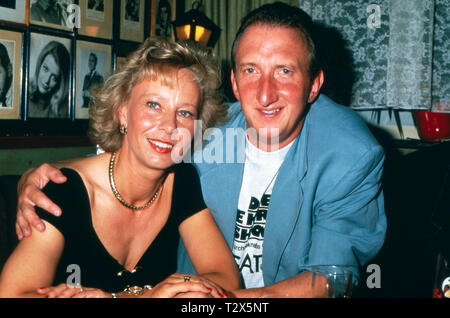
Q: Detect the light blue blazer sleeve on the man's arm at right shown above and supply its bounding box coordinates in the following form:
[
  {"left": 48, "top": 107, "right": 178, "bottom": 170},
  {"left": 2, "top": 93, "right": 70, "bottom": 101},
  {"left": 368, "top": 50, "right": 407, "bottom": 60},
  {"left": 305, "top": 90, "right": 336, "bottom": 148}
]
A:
[{"left": 309, "top": 146, "right": 386, "bottom": 283}]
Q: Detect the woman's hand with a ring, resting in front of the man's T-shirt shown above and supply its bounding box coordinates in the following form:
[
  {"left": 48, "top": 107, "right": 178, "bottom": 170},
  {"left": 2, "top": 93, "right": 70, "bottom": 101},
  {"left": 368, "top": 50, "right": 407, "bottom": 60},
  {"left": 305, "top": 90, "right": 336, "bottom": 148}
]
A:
[{"left": 143, "top": 273, "right": 230, "bottom": 298}]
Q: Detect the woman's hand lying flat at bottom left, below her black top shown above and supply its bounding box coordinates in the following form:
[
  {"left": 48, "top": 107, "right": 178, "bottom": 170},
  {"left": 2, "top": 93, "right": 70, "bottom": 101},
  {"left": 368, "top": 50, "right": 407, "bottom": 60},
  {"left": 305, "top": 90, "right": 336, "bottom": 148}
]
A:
[{"left": 37, "top": 283, "right": 111, "bottom": 298}]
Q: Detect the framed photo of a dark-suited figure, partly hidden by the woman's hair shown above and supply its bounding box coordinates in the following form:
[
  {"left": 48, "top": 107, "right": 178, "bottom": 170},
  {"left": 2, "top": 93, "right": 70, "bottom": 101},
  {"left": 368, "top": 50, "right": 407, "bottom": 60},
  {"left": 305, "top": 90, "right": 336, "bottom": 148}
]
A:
[{"left": 75, "top": 41, "right": 112, "bottom": 119}]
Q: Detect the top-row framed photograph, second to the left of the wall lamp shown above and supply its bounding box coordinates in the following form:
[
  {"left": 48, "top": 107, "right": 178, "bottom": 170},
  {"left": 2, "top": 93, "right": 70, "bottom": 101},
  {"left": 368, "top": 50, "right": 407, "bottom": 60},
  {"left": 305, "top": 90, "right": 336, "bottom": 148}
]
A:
[{"left": 120, "top": 0, "right": 145, "bottom": 43}]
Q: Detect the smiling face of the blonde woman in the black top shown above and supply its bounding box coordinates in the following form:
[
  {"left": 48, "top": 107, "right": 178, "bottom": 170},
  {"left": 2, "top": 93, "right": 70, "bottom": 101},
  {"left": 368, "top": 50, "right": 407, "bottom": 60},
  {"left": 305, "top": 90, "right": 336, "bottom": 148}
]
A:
[{"left": 119, "top": 69, "right": 200, "bottom": 169}]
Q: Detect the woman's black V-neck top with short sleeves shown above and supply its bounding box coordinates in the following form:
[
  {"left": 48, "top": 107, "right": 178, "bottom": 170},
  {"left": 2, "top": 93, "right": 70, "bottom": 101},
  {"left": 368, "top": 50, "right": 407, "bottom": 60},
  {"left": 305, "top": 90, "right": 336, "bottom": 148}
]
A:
[{"left": 36, "top": 163, "right": 206, "bottom": 292}]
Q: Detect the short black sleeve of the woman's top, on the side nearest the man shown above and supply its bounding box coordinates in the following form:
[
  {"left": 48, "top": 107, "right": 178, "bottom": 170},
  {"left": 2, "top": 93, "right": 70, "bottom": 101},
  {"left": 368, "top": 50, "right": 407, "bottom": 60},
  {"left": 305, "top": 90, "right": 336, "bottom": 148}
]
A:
[{"left": 172, "top": 163, "right": 206, "bottom": 224}]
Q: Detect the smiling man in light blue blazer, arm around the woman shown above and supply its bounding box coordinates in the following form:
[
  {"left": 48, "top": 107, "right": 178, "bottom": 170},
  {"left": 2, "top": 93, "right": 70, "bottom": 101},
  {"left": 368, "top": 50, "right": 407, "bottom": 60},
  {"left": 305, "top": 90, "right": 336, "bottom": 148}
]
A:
[{"left": 14, "top": 3, "right": 386, "bottom": 297}]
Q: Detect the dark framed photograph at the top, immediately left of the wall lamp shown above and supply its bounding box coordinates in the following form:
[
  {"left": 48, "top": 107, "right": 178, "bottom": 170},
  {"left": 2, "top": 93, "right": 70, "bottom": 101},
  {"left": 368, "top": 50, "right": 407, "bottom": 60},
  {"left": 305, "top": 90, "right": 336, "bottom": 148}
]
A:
[{"left": 150, "top": 0, "right": 177, "bottom": 39}]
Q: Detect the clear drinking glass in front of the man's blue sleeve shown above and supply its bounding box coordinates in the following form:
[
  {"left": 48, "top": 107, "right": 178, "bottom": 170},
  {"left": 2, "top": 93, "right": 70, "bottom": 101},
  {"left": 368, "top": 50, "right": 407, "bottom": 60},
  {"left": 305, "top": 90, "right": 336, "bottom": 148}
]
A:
[{"left": 311, "top": 265, "right": 352, "bottom": 298}]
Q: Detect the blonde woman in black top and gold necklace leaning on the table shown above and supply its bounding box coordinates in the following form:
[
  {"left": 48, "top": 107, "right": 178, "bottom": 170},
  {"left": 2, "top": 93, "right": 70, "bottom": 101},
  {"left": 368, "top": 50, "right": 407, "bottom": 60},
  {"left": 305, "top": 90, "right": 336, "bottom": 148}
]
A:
[{"left": 0, "top": 38, "right": 239, "bottom": 297}]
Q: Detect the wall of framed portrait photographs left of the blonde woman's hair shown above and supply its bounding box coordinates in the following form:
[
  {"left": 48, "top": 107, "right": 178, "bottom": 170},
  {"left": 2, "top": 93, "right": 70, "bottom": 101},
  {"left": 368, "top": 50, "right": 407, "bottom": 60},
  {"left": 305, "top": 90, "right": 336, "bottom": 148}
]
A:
[{"left": 0, "top": 0, "right": 184, "bottom": 149}]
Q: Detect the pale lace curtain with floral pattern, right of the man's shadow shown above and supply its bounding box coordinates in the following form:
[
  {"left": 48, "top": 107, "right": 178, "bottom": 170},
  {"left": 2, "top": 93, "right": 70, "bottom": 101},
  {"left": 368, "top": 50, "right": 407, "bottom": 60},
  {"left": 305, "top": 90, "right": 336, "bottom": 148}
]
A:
[{"left": 300, "top": 0, "right": 450, "bottom": 112}]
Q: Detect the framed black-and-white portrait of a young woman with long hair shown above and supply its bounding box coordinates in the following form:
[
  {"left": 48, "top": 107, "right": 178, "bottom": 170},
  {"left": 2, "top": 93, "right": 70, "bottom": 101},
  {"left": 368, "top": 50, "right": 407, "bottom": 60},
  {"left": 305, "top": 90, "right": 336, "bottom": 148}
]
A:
[{"left": 27, "top": 33, "right": 72, "bottom": 118}]
